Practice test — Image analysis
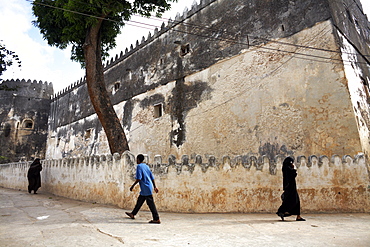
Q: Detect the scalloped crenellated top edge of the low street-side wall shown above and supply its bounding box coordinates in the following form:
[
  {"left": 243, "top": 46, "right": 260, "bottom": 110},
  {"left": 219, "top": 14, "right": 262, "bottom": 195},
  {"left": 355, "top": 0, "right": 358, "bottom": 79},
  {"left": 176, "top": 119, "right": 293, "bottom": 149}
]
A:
[{"left": 39, "top": 152, "right": 369, "bottom": 175}]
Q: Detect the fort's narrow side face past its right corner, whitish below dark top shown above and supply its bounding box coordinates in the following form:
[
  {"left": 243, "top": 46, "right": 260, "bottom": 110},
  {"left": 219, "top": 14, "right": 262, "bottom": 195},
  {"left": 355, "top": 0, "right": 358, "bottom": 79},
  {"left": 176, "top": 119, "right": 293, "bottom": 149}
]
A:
[{"left": 330, "top": 0, "right": 370, "bottom": 155}]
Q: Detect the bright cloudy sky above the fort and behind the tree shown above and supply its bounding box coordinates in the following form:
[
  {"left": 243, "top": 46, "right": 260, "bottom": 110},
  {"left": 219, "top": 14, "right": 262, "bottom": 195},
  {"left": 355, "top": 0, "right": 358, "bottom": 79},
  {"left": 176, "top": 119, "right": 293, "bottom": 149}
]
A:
[{"left": 0, "top": 0, "right": 370, "bottom": 93}]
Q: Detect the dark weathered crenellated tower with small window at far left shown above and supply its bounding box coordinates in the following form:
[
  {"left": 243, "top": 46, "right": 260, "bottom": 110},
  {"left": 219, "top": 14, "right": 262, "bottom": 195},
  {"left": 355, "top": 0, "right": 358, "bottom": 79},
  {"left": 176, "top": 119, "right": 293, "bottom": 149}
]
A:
[{"left": 0, "top": 80, "right": 53, "bottom": 163}]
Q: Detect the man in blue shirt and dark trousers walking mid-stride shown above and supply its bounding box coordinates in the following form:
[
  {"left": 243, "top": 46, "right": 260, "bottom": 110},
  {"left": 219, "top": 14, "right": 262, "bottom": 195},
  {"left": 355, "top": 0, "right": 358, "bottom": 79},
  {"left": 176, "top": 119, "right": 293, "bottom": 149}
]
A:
[{"left": 126, "top": 154, "right": 161, "bottom": 224}]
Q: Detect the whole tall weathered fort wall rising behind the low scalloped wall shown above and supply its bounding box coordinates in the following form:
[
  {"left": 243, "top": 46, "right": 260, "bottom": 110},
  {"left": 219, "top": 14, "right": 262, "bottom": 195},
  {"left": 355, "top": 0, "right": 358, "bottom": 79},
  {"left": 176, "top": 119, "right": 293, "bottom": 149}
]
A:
[{"left": 47, "top": 0, "right": 370, "bottom": 159}]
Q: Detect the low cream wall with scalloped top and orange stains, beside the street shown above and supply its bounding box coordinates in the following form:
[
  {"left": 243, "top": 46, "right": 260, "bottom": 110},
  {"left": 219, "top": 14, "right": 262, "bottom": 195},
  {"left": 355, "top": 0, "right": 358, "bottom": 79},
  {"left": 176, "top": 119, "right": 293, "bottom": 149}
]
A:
[{"left": 0, "top": 152, "right": 370, "bottom": 213}]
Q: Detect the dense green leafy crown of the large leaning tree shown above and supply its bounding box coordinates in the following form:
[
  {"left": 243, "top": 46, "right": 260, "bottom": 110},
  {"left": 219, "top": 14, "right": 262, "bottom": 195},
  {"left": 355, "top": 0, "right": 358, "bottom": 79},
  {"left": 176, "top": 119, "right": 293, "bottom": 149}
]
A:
[{"left": 32, "top": 0, "right": 177, "bottom": 66}]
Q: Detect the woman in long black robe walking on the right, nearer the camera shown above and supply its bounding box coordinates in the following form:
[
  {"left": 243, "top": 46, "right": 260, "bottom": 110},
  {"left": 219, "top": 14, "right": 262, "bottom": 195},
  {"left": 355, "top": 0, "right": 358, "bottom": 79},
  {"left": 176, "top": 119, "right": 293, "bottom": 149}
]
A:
[{"left": 276, "top": 157, "right": 305, "bottom": 221}]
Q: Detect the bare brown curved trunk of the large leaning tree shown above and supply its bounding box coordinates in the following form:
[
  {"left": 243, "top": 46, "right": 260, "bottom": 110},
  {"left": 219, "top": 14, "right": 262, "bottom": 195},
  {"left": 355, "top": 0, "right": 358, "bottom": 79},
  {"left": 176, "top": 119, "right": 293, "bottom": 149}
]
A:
[{"left": 83, "top": 20, "right": 129, "bottom": 154}]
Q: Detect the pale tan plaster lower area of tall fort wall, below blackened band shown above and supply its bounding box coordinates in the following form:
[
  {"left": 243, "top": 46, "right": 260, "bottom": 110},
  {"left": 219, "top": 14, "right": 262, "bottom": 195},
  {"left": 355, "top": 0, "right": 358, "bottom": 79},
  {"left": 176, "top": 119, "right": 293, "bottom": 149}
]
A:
[{"left": 48, "top": 21, "right": 364, "bottom": 161}]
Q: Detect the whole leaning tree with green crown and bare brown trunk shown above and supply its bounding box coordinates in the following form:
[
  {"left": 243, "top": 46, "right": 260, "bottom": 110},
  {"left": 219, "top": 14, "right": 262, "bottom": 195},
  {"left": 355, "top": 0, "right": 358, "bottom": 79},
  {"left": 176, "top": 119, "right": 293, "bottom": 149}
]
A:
[{"left": 32, "top": 0, "right": 177, "bottom": 154}]
